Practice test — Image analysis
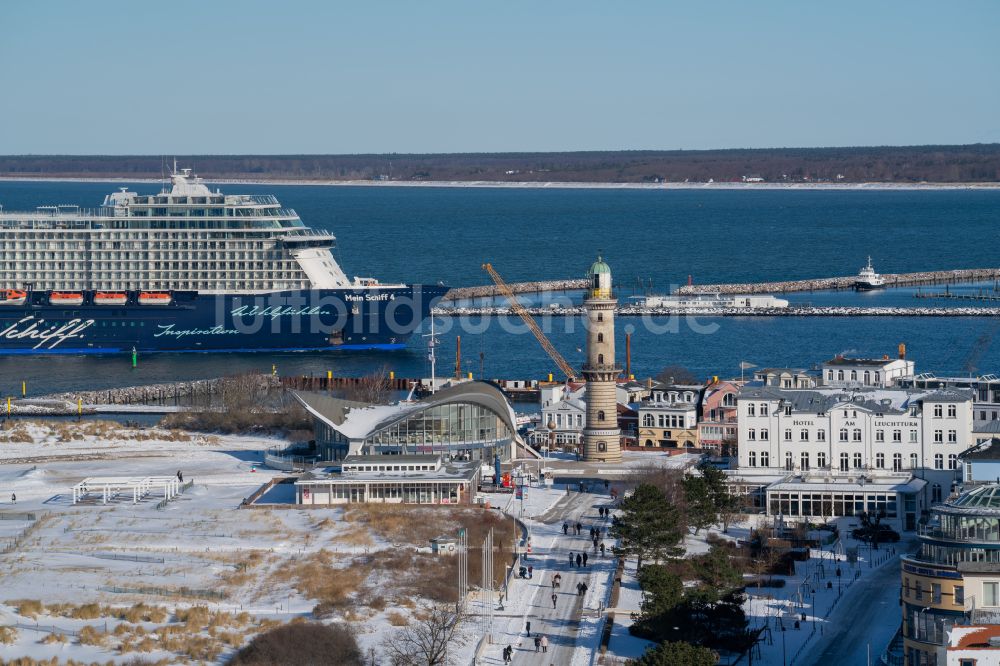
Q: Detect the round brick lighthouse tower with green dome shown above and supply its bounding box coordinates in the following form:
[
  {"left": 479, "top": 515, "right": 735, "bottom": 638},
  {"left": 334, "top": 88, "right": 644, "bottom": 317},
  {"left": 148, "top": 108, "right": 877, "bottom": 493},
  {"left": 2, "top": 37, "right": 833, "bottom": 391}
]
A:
[{"left": 583, "top": 257, "right": 622, "bottom": 463}]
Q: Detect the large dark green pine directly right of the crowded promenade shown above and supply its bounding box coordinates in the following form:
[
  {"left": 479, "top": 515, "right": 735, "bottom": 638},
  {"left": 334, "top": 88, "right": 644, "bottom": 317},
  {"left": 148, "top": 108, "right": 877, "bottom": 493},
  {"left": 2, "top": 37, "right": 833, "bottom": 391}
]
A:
[{"left": 611, "top": 483, "right": 684, "bottom": 570}]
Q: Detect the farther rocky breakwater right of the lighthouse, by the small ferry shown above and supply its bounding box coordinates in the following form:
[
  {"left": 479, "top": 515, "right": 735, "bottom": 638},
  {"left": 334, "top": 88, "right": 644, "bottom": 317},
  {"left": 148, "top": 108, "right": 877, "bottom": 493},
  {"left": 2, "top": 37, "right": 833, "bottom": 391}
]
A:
[{"left": 677, "top": 268, "right": 1000, "bottom": 294}]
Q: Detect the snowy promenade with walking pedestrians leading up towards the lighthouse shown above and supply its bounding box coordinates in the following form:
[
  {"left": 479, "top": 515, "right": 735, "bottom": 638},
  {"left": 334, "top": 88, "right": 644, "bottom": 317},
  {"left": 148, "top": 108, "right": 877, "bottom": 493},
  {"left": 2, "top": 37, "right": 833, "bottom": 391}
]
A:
[{"left": 484, "top": 492, "right": 614, "bottom": 666}]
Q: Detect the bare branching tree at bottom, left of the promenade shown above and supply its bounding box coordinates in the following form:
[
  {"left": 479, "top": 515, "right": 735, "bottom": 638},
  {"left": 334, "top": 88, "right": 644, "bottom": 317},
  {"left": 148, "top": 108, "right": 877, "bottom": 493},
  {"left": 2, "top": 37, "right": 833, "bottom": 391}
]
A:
[{"left": 382, "top": 604, "right": 464, "bottom": 666}]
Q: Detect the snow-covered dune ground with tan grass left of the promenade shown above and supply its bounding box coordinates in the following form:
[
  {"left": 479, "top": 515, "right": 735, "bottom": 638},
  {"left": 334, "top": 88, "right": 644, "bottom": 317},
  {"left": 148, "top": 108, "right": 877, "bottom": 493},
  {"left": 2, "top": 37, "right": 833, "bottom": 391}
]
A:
[{"left": 0, "top": 421, "right": 516, "bottom": 663}]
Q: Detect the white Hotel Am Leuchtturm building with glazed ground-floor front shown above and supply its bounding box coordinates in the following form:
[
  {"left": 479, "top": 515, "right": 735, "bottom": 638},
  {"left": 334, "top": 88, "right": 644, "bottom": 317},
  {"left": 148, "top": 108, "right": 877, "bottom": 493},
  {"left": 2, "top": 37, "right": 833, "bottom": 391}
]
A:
[{"left": 731, "top": 384, "right": 975, "bottom": 530}]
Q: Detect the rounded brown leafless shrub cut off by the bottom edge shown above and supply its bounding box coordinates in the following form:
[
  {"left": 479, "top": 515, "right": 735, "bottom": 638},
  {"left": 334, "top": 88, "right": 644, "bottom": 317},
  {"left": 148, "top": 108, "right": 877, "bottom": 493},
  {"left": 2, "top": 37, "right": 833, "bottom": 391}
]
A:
[{"left": 229, "top": 623, "right": 364, "bottom": 666}]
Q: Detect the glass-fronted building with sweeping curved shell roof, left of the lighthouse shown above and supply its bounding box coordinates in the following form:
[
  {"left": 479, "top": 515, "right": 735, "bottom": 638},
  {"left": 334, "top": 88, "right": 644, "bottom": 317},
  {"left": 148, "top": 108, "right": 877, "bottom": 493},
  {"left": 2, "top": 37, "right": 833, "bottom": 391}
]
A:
[{"left": 294, "top": 381, "right": 518, "bottom": 462}]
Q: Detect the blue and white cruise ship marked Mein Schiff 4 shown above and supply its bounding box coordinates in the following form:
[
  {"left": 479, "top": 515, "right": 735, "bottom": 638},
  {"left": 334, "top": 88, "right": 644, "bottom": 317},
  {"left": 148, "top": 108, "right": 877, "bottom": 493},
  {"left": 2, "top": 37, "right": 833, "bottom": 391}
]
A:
[{"left": 0, "top": 167, "right": 447, "bottom": 354}]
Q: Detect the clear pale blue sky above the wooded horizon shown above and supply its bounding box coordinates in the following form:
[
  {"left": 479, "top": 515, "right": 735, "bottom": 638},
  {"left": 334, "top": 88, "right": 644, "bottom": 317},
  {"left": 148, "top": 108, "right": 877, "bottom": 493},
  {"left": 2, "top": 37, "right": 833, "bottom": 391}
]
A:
[{"left": 0, "top": 0, "right": 1000, "bottom": 155}]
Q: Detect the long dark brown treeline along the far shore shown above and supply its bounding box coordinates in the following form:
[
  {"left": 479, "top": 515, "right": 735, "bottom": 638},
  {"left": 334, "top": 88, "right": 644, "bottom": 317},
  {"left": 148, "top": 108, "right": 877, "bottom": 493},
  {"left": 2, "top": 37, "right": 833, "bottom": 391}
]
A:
[{"left": 0, "top": 144, "right": 1000, "bottom": 183}]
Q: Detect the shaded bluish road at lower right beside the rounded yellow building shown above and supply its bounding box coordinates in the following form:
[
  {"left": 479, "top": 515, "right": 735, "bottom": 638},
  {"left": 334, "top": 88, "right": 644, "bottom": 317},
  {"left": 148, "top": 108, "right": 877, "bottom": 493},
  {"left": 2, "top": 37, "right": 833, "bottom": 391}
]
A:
[{"left": 795, "top": 543, "right": 912, "bottom": 666}]
